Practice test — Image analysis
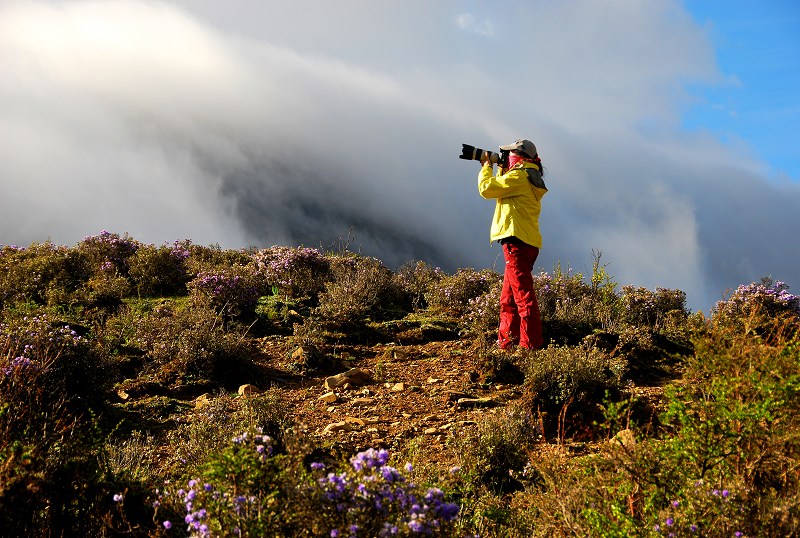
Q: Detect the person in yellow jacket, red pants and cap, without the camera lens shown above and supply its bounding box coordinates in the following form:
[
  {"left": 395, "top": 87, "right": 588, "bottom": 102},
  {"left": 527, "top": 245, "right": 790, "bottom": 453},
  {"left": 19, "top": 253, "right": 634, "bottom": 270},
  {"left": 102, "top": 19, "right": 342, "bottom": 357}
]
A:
[{"left": 478, "top": 136, "right": 547, "bottom": 349}]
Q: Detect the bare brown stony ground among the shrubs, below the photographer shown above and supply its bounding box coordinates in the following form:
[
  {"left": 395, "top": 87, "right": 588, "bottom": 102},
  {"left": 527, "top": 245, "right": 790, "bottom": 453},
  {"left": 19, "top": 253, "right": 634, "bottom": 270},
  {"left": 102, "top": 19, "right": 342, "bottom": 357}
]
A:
[{"left": 169, "top": 330, "right": 661, "bottom": 466}]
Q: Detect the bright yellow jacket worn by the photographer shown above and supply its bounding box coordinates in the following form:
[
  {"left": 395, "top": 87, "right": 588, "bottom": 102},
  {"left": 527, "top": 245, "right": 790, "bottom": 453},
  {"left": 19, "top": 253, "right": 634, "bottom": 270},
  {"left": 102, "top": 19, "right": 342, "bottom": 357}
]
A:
[{"left": 478, "top": 162, "right": 547, "bottom": 248}]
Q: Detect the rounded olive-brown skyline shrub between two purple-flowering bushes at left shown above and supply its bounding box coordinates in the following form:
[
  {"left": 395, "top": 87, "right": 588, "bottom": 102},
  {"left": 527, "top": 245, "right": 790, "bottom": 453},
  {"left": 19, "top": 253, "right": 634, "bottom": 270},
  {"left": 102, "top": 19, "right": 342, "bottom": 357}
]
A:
[{"left": 129, "top": 241, "right": 191, "bottom": 296}]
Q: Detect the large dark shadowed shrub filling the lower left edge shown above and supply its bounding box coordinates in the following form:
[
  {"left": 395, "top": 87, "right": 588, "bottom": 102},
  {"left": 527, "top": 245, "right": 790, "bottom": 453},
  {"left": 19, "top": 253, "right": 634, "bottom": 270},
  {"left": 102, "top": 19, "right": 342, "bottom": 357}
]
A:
[{"left": 0, "top": 316, "right": 118, "bottom": 536}]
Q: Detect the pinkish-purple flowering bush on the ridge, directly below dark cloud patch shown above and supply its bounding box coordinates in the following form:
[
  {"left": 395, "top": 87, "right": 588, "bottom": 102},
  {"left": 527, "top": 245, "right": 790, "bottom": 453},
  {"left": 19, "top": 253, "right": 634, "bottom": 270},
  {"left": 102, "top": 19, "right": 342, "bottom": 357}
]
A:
[{"left": 253, "top": 246, "right": 330, "bottom": 295}]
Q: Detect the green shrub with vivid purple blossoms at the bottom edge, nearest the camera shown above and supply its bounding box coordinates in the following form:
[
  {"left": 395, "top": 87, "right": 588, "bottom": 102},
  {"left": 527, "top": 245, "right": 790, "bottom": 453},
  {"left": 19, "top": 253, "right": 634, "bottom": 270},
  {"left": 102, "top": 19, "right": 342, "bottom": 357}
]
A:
[{"left": 156, "top": 440, "right": 458, "bottom": 538}]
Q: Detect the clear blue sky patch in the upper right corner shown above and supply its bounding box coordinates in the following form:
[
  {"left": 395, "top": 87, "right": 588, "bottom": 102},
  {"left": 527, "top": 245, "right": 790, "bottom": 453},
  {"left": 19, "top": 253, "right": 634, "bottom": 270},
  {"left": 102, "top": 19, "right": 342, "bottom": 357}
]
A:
[{"left": 684, "top": 0, "right": 800, "bottom": 181}]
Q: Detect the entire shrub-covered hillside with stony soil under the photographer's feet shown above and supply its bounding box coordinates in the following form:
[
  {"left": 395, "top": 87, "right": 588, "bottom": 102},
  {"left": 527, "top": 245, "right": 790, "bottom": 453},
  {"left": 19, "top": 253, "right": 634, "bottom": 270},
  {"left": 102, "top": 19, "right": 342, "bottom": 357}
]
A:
[{"left": 0, "top": 232, "right": 800, "bottom": 536}]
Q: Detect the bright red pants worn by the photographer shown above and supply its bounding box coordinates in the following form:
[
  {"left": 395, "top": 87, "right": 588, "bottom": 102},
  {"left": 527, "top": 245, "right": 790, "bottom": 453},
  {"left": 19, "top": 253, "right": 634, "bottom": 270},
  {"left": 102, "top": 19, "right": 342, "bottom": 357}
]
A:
[{"left": 497, "top": 241, "right": 544, "bottom": 349}]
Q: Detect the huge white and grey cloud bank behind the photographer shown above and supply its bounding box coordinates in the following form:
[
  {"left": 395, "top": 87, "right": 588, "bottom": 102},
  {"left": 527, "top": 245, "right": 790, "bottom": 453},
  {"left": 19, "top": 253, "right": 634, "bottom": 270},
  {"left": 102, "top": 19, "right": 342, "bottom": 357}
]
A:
[{"left": 0, "top": 0, "right": 800, "bottom": 308}]
